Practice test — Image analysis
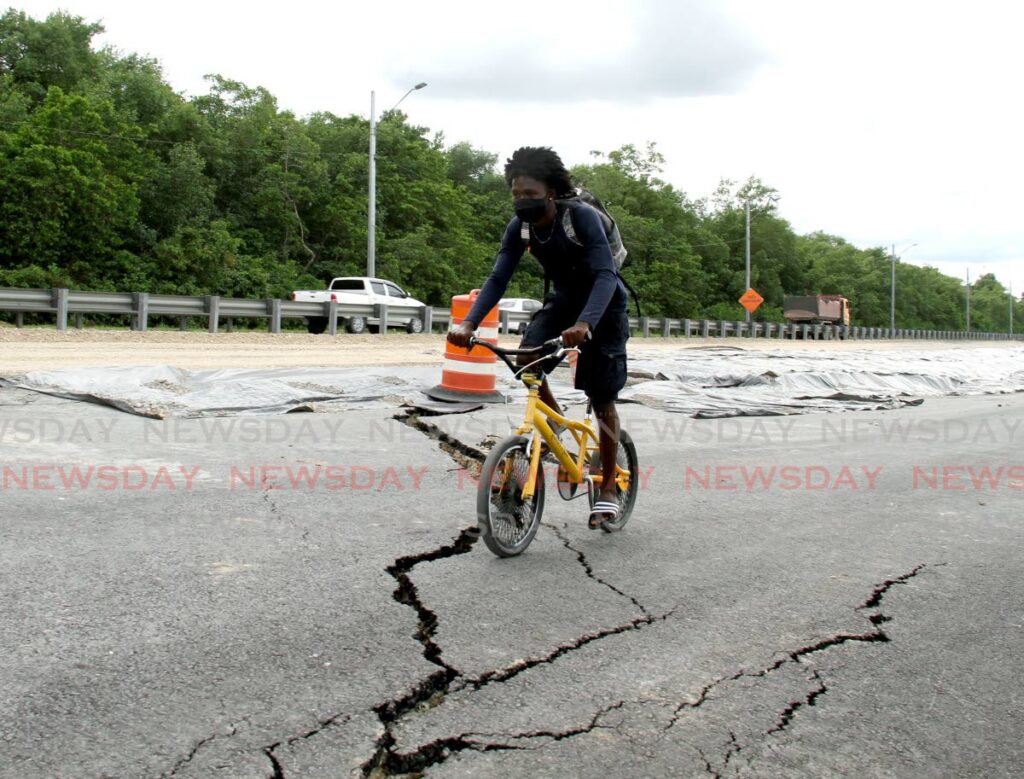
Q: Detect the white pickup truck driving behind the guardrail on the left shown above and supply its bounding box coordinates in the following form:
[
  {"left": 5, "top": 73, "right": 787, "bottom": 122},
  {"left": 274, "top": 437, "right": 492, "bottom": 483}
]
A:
[{"left": 292, "top": 276, "right": 424, "bottom": 334}]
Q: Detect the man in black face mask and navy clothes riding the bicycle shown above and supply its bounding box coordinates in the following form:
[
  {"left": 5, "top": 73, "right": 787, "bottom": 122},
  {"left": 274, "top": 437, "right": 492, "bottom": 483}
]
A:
[{"left": 447, "top": 146, "right": 630, "bottom": 528}]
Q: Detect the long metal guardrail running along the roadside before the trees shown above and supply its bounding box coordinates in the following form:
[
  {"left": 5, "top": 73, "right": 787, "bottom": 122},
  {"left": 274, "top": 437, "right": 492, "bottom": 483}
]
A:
[{"left": 0, "top": 288, "right": 1024, "bottom": 341}]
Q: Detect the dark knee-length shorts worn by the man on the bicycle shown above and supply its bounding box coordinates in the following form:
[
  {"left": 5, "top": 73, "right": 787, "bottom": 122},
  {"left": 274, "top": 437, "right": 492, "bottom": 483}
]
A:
[{"left": 519, "top": 295, "right": 630, "bottom": 403}]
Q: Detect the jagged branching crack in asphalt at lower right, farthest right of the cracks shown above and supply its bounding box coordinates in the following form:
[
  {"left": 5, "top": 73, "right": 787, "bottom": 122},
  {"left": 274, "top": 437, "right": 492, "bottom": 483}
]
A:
[{"left": 665, "top": 563, "right": 945, "bottom": 779}]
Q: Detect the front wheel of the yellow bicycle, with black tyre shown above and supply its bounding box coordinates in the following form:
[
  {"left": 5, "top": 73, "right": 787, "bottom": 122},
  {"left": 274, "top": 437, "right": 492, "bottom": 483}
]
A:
[{"left": 476, "top": 435, "right": 544, "bottom": 557}]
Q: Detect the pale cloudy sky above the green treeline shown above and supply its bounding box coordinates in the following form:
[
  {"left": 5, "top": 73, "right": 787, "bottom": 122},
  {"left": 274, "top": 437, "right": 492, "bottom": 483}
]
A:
[{"left": 11, "top": 0, "right": 1024, "bottom": 295}]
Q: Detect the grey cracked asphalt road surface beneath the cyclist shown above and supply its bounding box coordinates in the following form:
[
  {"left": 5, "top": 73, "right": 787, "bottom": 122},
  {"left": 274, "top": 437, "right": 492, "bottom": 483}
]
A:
[{"left": 0, "top": 389, "right": 1024, "bottom": 779}]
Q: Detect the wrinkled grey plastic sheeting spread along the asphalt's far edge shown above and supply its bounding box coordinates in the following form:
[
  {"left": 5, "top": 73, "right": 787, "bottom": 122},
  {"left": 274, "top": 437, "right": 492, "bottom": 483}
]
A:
[{"left": 0, "top": 346, "right": 1024, "bottom": 419}]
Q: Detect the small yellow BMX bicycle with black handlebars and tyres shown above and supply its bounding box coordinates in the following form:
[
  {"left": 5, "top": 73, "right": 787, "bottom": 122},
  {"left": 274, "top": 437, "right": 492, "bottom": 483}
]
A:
[{"left": 470, "top": 338, "right": 639, "bottom": 557}]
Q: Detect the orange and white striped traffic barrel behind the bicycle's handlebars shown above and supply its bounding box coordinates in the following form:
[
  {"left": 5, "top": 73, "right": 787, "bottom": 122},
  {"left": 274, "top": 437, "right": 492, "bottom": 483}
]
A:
[{"left": 427, "top": 290, "right": 505, "bottom": 403}]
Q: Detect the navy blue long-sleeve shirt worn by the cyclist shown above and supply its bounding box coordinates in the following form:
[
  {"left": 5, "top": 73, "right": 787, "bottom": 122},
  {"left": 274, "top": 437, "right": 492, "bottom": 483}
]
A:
[{"left": 466, "top": 203, "right": 626, "bottom": 330}]
